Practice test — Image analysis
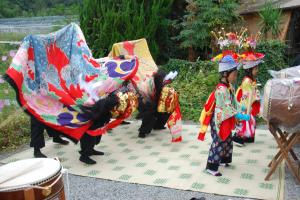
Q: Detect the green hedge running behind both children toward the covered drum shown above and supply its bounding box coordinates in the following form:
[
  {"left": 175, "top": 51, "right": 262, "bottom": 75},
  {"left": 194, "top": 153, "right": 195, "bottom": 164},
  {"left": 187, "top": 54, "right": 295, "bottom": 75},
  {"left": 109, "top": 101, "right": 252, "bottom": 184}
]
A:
[{"left": 162, "top": 40, "right": 287, "bottom": 121}]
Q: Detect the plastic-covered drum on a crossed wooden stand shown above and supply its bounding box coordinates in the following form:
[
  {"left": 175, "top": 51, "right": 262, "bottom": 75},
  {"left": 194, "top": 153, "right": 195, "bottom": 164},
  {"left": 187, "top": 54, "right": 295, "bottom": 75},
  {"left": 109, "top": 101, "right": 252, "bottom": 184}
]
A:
[{"left": 262, "top": 78, "right": 300, "bottom": 132}]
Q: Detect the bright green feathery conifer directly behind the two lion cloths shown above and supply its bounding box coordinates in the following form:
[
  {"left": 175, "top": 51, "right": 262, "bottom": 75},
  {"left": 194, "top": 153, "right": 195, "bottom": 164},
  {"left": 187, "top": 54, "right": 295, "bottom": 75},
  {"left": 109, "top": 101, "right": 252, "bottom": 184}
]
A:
[{"left": 80, "top": 0, "right": 173, "bottom": 62}]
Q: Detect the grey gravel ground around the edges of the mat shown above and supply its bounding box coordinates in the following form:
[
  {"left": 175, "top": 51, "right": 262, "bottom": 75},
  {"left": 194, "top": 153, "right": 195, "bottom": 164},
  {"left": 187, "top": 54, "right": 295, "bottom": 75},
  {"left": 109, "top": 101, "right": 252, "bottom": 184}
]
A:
[{"left": 0, "top": 127, "right": 300, "bottom": 200}]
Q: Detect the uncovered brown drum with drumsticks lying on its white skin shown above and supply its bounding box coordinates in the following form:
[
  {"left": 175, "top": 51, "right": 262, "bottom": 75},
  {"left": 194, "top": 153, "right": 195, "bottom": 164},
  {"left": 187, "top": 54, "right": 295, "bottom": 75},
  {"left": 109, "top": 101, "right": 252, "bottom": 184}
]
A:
[{"left": 0, "top": 158, "right": 65, "bottom": 200}]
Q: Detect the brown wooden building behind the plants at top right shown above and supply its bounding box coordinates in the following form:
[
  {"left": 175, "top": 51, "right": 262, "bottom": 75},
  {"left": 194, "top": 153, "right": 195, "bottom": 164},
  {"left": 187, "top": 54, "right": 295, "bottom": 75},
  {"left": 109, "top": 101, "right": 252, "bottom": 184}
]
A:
[{"left": 238, "top": 0, "right": 300, "bottom": 57}]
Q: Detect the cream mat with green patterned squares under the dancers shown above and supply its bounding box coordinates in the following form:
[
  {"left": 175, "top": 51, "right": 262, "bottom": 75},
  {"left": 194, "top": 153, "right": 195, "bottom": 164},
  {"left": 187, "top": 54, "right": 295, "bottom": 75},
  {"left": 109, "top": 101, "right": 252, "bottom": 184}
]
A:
[{"left": 1, "top": 122, "right": 284, "bottom": 200}]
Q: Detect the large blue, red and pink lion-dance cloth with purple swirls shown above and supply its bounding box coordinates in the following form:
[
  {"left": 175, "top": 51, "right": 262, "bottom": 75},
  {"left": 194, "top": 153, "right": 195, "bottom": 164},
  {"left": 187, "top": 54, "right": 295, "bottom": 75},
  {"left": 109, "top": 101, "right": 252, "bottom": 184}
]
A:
[{"left": 6, "top": 23, "right": 139, "bottom": 141}]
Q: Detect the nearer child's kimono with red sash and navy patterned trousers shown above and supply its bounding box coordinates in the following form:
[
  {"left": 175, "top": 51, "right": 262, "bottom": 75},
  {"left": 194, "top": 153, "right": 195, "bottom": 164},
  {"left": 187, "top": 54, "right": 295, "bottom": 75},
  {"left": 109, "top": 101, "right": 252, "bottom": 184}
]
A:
[{"left": 206, "top": 84, "right": 240, "bottom": 171}]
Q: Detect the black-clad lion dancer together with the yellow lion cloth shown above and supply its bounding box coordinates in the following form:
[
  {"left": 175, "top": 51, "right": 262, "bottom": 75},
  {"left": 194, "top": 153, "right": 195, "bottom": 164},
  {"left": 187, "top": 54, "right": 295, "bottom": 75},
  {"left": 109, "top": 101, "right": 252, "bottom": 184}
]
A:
[{"left": 109, "top": 39, "right": 182, "bottom": 142}]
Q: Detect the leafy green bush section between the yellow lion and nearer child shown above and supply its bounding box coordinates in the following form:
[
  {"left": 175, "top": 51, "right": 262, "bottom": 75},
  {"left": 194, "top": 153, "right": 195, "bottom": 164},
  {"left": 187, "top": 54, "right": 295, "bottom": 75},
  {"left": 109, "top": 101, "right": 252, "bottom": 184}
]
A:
[{"left": 162, "top": 59, "right": 219, "bottom": 121}]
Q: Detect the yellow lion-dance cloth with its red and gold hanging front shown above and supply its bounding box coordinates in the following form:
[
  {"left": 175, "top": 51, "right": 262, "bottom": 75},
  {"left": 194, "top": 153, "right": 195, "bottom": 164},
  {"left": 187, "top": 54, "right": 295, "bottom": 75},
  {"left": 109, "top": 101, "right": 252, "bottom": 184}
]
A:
[{"left": 109, "top": 39, "right": 182, "bottom": 142}]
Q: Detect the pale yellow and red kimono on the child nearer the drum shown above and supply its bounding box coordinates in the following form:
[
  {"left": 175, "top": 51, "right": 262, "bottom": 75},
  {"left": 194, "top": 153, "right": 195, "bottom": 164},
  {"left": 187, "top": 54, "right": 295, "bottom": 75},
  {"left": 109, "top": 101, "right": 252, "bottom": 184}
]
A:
[{"left": 236, "top": 76, "right": 260, "bottom": 142}]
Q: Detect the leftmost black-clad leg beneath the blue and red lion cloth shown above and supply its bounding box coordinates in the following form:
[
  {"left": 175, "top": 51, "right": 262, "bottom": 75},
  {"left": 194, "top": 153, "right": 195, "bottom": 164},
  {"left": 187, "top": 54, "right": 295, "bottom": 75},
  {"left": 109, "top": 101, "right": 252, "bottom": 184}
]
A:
[{"left": 30, "top": 117, "right": 47, "bottom": 158}]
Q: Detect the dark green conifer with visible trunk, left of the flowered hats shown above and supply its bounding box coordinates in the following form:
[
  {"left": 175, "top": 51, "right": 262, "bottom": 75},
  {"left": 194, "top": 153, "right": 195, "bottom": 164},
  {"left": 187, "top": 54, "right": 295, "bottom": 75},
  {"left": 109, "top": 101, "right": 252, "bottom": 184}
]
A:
[{"left": 175, "top": 0, "right": 240, "bottom": 61}]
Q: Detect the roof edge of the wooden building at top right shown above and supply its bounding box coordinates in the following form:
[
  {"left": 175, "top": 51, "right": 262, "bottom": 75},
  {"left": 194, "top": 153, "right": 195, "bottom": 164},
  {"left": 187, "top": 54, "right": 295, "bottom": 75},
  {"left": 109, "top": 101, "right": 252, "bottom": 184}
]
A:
[{"left": 238, "top": 0, "right": 300, "bottom": 14}]
